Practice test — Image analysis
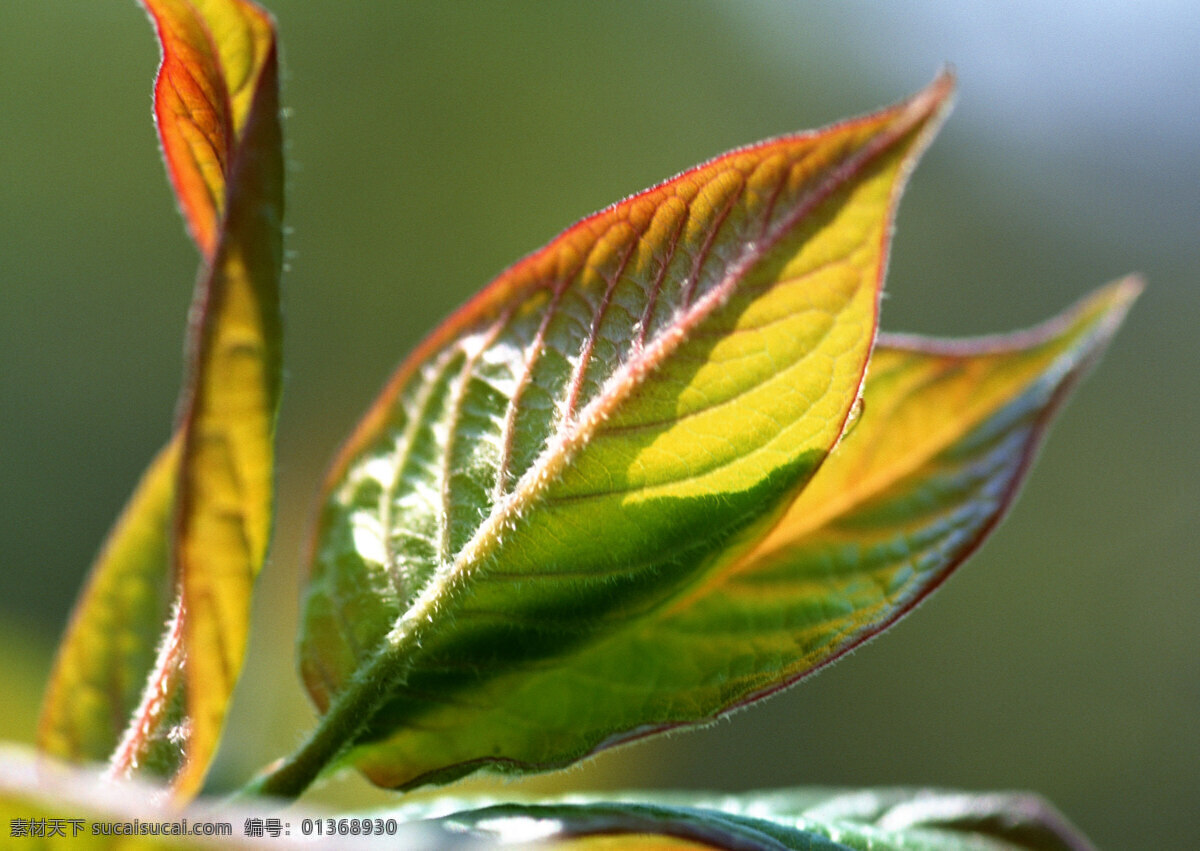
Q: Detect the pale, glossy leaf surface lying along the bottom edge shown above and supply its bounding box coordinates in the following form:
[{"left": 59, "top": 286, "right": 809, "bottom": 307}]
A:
[{"left": 0, "top": 745, "right": 1091, "bottom": 851}]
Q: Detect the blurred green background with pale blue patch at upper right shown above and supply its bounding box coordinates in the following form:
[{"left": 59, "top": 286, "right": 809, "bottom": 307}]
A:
[{"left": 0, "top": 0, "right": 1200, "bottom": 849}]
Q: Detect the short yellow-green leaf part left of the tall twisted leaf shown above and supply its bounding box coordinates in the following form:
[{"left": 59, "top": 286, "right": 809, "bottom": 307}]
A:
[{"left": 37, "top": 439, "right": 179, "bottom": 762}]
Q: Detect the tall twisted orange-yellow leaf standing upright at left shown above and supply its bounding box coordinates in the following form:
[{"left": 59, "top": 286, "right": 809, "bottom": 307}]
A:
[{"left": 145, "top": 0, "right": 283, "bottom": 798}]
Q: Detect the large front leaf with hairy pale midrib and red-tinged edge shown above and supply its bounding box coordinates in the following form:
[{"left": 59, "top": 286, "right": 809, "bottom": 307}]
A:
[{"left": 283, "top": 76, "right": 952, "bottom": 793}]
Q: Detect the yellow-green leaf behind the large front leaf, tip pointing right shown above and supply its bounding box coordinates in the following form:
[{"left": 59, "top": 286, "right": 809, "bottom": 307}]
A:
[{"left": 297, "top": 265, "right": 1141, "bottom": 785}]
